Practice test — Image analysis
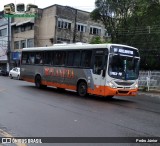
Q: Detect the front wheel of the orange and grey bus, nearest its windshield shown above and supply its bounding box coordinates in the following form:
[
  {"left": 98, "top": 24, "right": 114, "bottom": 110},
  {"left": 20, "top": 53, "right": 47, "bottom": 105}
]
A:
[{"left": 77, "top": 81, "right": 87, "bottom": 97}]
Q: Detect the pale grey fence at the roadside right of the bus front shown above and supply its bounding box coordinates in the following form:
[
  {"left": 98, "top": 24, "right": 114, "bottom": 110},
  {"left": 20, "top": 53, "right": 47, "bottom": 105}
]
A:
[{"left": 138, "top": 71, "right": 160, "bottom": 91}]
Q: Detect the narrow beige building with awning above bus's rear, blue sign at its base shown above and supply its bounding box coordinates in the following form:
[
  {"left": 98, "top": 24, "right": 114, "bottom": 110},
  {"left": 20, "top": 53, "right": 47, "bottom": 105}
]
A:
[{"left": 11, "top": 17, "right": 35, "bottom": 66}]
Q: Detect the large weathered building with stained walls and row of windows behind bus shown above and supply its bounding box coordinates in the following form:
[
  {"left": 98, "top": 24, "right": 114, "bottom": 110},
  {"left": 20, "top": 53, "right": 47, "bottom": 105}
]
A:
[{"left": 38, "top": 5, "right": 108, "bottom": 46}]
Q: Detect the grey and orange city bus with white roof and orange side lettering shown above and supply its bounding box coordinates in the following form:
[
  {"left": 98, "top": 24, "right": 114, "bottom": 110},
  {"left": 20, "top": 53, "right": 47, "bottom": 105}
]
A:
[{"left": 20, "top": 43, "right": 140, "bottom": 98}]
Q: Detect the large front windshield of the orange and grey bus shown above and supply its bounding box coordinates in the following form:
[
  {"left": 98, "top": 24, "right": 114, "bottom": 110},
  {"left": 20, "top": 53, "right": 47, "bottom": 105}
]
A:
[{"left": 108, "top": 54, "right": 139, "bottom": 80}]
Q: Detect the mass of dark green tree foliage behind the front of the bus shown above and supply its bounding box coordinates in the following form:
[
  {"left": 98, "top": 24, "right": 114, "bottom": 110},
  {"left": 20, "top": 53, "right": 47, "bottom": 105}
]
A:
[{"left": 91, "top": 0, "right": 160, "bottom": 70}]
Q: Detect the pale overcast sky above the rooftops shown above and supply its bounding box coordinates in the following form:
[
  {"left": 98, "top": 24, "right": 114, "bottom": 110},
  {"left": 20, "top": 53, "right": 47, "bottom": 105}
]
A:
[{"left": 0, "top": 0, "right": 95, "bottom": 12}]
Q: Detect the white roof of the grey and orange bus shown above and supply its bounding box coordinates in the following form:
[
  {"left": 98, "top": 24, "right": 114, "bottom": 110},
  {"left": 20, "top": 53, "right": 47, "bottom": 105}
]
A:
[{"left": 22, "top": 44, "right": 138, "bottom": 51}]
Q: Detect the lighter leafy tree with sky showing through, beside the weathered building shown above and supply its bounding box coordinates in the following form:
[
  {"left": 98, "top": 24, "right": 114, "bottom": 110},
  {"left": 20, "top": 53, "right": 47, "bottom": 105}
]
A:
[{"left": 91, "top": 0, "right": 135, "bottom": 43}]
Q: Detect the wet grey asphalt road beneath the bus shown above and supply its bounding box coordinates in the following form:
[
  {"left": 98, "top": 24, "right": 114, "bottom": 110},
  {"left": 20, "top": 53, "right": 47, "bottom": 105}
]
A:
[{"left": 0, "top": 76, "right": 160, "bottom": 146}]
